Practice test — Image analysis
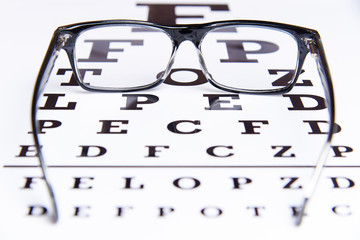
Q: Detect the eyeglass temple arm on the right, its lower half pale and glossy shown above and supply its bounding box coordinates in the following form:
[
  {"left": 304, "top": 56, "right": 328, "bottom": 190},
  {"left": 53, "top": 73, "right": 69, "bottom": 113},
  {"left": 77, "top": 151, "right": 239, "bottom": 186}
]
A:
[{"left": 296, "top": 34, "right": 335, "bottom": 225}]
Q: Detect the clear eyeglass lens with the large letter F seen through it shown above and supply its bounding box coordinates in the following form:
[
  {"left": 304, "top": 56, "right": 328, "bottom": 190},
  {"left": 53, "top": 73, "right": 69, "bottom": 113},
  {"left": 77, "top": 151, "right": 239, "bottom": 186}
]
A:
[{"left": 74, "top": 25, "right": 173, "bottom": 91}]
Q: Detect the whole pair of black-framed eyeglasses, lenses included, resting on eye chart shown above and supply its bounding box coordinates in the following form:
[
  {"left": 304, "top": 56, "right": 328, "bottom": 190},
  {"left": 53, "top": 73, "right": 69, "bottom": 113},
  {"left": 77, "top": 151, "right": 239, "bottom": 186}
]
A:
[{"left": 31, "top": 20, "right": 335, "bottom": 224}]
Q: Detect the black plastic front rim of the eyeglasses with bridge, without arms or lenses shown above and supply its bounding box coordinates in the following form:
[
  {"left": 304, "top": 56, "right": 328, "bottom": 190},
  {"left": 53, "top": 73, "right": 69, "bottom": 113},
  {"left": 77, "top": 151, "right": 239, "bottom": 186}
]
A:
[{"left": 58, "top": 20, "right": 317, "bottom": 93}]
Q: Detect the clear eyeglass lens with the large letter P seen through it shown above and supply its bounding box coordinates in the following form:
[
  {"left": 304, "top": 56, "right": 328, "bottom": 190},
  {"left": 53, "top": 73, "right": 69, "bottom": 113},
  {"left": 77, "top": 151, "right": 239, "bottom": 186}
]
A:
[{"left": 201, "top": 25, "right": 298, "bottom": 91}]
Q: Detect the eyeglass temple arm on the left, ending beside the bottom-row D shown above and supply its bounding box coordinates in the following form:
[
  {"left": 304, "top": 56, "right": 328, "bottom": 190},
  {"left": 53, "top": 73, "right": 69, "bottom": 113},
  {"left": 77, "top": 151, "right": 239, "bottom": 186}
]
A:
[{"left": 31, "top": 29, "right": 64, "bottom": 223}]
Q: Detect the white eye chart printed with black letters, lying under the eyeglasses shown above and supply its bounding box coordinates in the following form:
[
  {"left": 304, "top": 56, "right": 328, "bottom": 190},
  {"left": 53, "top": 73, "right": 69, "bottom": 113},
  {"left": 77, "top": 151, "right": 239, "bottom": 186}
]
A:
[{"left": 0, "top": 1, "right": 360, "bottom": 239}]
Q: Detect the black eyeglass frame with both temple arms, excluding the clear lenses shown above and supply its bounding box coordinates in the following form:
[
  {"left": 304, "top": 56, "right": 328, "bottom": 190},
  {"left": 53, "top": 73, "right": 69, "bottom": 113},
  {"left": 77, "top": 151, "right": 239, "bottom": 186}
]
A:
[{"left": 31, "top": 20, "right": 335, "bottom": 224}]
